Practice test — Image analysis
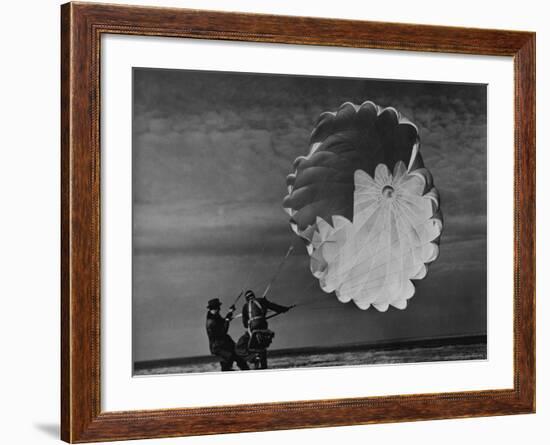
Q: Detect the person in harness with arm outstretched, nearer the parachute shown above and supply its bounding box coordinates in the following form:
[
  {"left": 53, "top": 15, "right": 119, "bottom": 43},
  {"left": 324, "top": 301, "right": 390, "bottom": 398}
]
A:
[{"left": 239, "top": 290, "right": 291, "bottom": 369}]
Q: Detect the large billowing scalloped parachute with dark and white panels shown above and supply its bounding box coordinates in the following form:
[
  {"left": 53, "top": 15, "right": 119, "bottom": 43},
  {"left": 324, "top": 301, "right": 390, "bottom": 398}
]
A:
[{"left": 283, "top": 101, "right": 443, "bottom": 312}]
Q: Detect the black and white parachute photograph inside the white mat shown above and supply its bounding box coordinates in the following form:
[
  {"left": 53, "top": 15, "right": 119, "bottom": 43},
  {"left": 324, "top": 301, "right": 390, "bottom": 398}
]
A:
[{"left": 132, "top": 67, "right": 487, "bottom": 376}]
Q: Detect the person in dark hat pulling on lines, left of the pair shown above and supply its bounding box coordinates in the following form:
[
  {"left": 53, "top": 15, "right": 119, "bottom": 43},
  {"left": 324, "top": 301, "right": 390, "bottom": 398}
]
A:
[{"left": 206, "top": 298, "right": 250, "bottom": 371}]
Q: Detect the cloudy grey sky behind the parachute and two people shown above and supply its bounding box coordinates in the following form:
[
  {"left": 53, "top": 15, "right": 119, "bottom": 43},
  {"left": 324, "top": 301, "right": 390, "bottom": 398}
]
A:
[{"left": 133, "top": 68, "right": 487, "bottom": 360}]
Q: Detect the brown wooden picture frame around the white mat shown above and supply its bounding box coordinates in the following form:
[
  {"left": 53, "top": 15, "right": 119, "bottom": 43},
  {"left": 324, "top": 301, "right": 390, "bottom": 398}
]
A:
[{"left": 61, "top": 3, "right": 535, "bottom": 443}]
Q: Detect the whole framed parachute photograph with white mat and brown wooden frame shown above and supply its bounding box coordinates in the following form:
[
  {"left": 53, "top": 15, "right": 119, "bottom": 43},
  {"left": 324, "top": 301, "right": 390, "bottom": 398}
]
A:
[{"left": 61, "top": 3, "right": 535, "bottom": 443}]
